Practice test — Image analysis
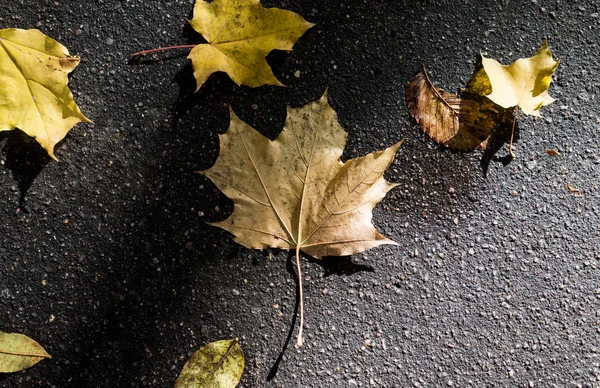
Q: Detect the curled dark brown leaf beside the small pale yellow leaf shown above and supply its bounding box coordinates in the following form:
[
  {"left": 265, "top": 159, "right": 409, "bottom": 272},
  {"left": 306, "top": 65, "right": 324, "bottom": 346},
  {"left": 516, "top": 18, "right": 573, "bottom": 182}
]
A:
[{"left": 406, "top": 67, "right": 513, "bottom": 151}]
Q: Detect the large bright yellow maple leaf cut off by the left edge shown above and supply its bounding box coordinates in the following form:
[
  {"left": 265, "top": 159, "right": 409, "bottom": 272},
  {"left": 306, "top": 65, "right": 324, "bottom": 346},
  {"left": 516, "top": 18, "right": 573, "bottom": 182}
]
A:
[{"left": 0, "top": 28, "right": 91, "bottom": 160}]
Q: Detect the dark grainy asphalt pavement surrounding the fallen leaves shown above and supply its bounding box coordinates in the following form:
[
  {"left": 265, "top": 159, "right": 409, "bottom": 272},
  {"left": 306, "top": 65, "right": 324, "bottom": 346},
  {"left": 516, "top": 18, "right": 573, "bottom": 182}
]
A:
[{"left": 0, "top": 0, "right": 600, "bottom": 388}]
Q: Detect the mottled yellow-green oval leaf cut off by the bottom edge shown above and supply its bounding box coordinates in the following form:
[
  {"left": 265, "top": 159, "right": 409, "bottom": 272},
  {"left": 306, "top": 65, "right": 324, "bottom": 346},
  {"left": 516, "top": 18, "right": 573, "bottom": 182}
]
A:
[{"left": 174, "top": 338, "right": 244, "bottom": 388}]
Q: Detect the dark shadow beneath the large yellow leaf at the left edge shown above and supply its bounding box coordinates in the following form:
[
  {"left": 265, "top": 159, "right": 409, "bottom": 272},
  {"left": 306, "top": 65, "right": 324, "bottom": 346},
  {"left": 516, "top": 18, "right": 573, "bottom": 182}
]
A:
[{"left": 0, "top": 130, "right": 51, "bottom": 212}]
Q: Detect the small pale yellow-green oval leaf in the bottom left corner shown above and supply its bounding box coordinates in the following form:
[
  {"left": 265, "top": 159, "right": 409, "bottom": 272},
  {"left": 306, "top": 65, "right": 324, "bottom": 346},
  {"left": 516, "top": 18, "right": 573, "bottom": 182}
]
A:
[{"left": 0, "top": 332, "right": 50, "bottom": 373}]
